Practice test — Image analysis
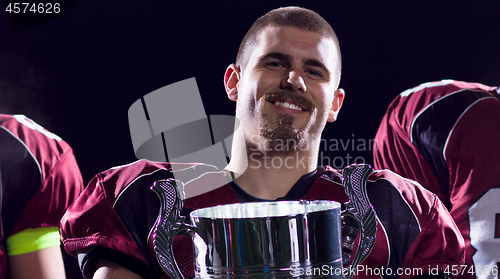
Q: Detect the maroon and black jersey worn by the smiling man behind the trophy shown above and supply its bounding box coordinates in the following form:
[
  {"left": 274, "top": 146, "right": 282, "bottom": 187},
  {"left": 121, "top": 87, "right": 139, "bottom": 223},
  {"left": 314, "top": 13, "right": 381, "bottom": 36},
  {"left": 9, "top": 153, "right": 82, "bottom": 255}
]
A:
[{"left": 61, "top": 160, "right": 464, "bottom": 278}]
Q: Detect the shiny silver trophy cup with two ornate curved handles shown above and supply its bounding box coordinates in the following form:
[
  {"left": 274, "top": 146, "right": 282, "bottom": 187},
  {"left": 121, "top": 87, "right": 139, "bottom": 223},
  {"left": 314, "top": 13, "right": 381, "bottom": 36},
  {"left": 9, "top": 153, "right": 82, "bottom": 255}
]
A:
[{"left": 152, "top": 165, "right": 377, "bottom": 279}]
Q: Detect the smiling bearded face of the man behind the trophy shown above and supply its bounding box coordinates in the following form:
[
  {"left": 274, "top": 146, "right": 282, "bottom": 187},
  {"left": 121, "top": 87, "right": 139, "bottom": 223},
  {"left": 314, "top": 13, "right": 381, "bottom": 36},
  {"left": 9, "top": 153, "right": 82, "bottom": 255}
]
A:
[{"left": 229, "top": 26, "right": 343, "bottom": 152}]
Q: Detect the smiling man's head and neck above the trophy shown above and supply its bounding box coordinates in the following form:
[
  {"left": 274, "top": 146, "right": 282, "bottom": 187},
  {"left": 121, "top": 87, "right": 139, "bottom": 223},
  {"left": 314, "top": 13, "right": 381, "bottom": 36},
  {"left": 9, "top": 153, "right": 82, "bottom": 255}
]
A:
[{"left": 225, "top": 18, "right": 344, "bottom": 199}]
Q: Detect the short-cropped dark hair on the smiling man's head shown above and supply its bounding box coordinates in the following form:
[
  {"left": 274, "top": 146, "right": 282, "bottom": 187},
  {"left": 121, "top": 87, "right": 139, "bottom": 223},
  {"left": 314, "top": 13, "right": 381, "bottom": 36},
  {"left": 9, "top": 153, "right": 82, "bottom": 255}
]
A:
[{"left": 236, "top": 7, "right": 341, "bottom": 76}]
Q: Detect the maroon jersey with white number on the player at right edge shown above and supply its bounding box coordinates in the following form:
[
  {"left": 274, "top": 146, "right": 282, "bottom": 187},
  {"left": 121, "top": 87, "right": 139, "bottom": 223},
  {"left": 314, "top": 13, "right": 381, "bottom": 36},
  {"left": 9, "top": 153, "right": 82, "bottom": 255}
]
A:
[{"left": 374, "top": 80, "right": 500, "bottom": 278}]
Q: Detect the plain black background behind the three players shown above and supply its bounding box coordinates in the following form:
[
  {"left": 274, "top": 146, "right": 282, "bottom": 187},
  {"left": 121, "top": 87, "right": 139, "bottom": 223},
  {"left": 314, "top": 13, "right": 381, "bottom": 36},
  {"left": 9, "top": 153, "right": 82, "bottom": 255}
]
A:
[{"left": 0, "top": 0, "right": 500, "bottom": 183}]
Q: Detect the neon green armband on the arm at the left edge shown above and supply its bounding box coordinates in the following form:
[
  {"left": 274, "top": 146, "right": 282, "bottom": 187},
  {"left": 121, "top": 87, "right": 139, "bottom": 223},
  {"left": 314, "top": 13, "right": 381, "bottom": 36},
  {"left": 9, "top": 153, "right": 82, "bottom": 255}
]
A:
[{"left": 6, "top": 227, "right": 61, "bottom": 256}]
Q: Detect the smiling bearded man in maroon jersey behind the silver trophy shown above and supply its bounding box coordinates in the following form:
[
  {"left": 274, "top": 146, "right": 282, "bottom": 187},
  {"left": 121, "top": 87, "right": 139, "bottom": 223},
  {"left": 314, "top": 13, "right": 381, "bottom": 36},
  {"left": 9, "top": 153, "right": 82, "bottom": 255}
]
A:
[{"left": 62, "top": 7, "right": 464, "bottom": 278}]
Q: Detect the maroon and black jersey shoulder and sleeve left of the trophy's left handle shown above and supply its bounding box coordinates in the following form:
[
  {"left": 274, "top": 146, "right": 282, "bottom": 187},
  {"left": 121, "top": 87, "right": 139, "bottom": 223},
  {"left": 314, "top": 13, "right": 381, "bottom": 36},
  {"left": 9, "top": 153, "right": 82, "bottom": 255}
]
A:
[{"left": 61, "top": 160, "right": 188, "bottom": 278}]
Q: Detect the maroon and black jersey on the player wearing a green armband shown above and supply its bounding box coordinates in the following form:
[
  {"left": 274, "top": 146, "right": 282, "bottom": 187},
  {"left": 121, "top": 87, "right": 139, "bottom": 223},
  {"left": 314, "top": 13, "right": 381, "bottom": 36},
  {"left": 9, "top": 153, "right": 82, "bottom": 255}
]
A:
[{"left": 0, "top": 114, "right": 83, "bottom": 278}]
